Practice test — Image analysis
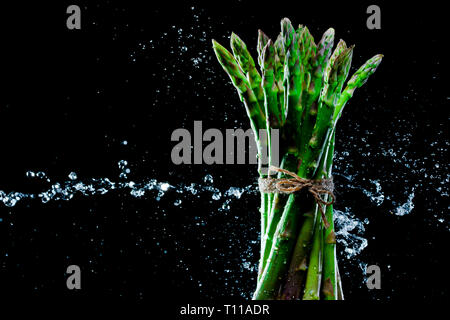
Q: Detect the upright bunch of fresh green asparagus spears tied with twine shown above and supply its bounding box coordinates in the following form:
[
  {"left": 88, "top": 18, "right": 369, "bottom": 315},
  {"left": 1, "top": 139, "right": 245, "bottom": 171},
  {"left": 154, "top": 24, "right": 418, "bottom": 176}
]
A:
[{"left": 213, "top": 18, "right": 383, "bottom": 300}]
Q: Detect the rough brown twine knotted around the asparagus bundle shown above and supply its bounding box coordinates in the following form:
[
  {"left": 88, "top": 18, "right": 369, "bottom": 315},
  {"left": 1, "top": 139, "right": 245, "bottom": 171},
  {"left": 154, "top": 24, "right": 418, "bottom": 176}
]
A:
[{"left": 258, "top": 166, "right": 335, "bottom": 229}]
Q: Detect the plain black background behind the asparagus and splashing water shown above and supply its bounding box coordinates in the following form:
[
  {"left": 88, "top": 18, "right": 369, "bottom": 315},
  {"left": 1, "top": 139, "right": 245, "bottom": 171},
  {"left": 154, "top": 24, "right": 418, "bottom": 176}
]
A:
[{"left": 0, "top": 1, "right": 448, "bottom": 310}]
